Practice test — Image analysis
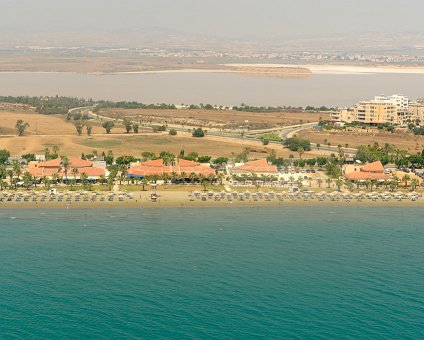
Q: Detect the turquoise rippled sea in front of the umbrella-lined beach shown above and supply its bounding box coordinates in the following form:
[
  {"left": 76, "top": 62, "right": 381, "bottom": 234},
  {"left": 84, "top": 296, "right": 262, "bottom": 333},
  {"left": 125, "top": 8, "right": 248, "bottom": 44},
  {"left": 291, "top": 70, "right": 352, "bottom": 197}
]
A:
[{"left": 0, "top": 207, "right": 424, "bottom": 339}]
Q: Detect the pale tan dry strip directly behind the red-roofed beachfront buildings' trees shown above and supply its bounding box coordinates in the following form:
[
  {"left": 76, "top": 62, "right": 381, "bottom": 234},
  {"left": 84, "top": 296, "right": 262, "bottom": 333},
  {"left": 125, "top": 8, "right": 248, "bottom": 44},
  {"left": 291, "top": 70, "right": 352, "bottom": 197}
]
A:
[{"left": 0, "top": 133, "right": 324, "bottom": 159}]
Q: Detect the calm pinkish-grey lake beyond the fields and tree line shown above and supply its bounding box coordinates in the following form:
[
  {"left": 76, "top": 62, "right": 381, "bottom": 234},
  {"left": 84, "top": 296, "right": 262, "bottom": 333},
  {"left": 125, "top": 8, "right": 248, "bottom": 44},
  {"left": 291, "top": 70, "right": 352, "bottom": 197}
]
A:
[{"left": 0, "top": 73, "right": 424, "bottom": 106}]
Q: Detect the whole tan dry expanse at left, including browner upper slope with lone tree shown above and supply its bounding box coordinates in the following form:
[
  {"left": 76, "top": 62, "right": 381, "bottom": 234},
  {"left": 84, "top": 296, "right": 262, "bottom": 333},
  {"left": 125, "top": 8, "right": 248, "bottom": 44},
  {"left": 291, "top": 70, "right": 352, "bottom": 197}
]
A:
[{"left": 0, "top": 111, "right": 328, "bottom": 159}]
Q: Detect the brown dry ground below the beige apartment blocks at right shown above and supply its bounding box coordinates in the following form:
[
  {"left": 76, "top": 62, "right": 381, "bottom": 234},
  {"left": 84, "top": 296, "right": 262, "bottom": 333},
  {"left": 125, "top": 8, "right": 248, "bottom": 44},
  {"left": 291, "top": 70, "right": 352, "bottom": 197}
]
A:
[{"left": 297, "top": 130, "right": 424, "bottom": 153}]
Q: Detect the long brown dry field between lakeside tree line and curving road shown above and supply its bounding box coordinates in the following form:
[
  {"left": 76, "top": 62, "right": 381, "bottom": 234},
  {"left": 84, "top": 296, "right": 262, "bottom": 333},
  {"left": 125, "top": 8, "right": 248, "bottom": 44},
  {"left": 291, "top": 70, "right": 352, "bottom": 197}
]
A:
[{"left": 99, "top": 109, "right": 329, "bottom": 126}]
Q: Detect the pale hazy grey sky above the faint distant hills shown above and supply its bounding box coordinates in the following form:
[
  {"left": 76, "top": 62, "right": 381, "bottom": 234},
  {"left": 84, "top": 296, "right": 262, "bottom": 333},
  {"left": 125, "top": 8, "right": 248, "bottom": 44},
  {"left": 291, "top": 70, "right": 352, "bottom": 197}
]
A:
[{"left": 0, "top": 0, "right": 424, "bottom": 39}]
